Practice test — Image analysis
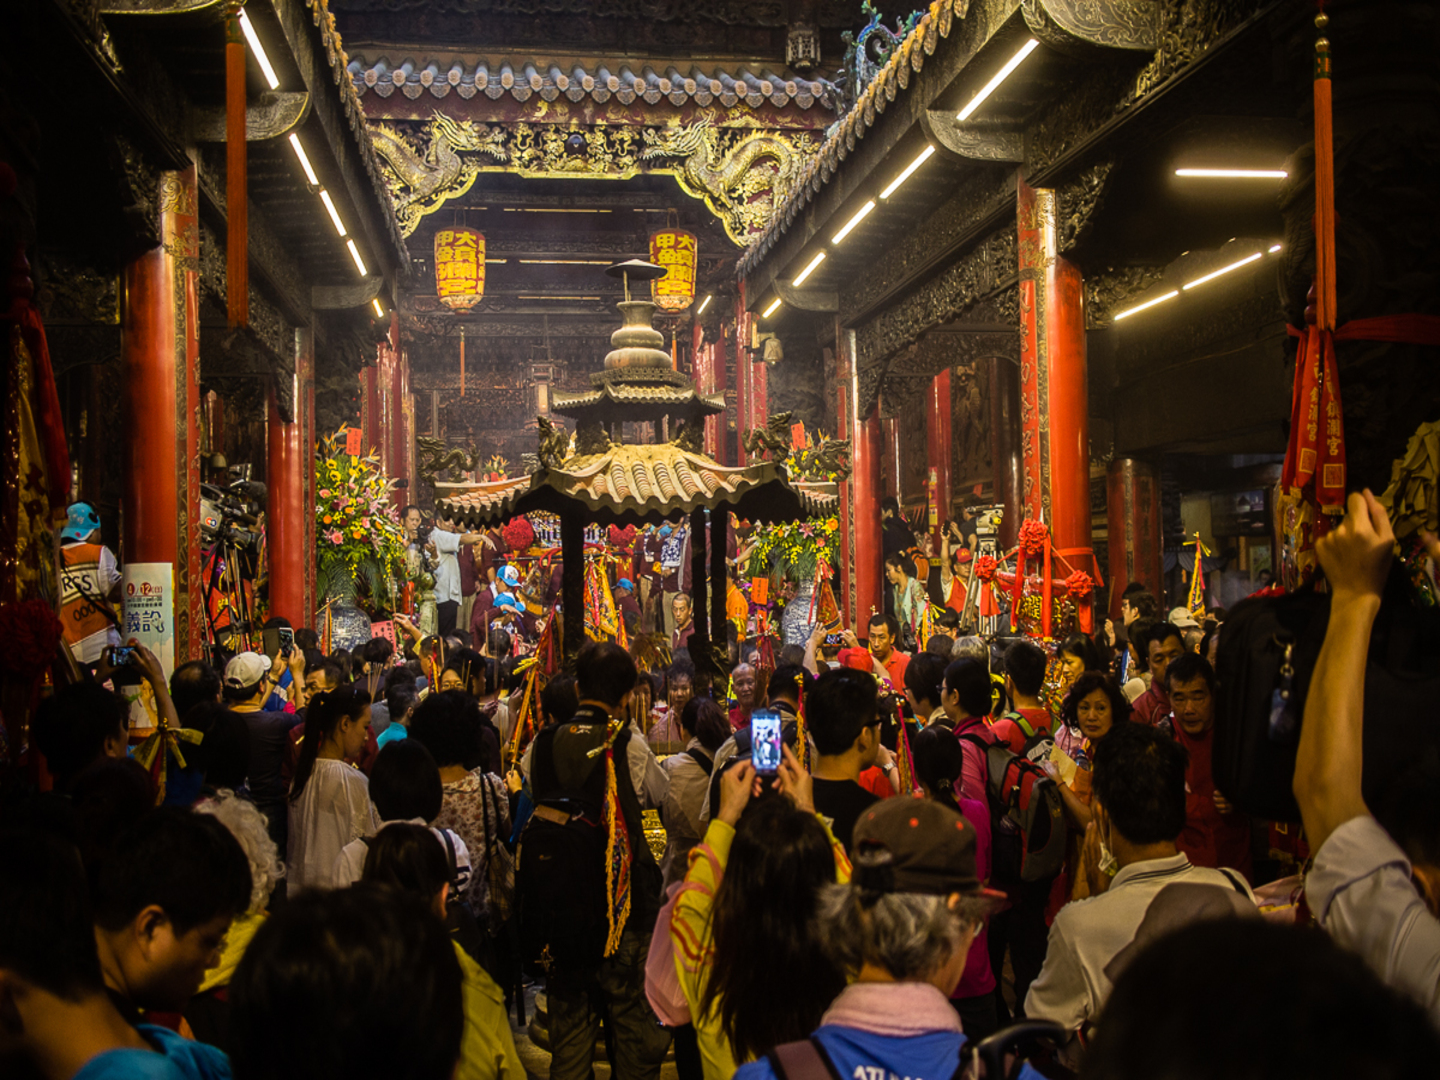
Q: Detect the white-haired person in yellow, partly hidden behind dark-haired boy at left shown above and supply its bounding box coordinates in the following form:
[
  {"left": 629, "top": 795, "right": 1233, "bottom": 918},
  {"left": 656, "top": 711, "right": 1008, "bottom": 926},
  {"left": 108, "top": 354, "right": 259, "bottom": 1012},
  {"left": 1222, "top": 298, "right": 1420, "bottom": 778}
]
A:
[{"left": 184, "top": 788, "right": 285, "bottom": 1051}]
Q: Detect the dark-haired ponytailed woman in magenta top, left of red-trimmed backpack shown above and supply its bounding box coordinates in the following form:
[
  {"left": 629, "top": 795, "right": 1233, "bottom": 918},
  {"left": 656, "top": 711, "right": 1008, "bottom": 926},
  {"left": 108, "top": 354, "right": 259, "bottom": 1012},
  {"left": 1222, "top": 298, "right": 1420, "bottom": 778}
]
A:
[{"left": 913, "top": 727, "right": 1005, "bottom": 1041}]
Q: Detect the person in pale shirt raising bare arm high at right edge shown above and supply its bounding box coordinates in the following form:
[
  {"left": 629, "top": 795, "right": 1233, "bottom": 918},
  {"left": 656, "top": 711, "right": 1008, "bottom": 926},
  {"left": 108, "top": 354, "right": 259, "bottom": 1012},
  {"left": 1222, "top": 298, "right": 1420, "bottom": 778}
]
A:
[{"left": 1293, "top": 488, "right": 1440, "bottom": 1024}]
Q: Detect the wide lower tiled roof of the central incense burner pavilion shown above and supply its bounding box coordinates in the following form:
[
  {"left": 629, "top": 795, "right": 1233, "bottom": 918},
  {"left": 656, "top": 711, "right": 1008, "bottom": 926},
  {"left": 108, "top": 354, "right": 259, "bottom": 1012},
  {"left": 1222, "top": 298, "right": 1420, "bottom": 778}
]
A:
[{"left": 435, "top": 442, "right": 838, "bottom": 527}]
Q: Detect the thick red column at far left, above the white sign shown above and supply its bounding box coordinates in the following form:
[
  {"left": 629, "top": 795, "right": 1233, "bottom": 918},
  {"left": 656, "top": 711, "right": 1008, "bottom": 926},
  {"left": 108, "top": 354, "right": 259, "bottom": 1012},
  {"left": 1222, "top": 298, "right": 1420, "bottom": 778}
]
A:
[{"left": 121, "top": 228, "right": 184, "bottom": 576}]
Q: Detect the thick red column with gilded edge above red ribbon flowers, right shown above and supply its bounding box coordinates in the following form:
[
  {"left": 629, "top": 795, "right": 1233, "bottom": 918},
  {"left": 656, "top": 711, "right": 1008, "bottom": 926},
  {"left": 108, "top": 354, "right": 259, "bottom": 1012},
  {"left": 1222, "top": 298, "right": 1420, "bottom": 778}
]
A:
[{"left": 1018, "top": 180, "right": 1096, "bottom": 573}]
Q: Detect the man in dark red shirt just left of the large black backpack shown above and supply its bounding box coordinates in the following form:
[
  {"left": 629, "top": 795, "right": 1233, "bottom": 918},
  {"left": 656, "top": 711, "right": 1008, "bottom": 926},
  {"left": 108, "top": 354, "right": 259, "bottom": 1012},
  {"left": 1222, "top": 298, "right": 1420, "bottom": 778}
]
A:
[{"left": 1165, "top": 652, "right": 1253, "bottom": 880}]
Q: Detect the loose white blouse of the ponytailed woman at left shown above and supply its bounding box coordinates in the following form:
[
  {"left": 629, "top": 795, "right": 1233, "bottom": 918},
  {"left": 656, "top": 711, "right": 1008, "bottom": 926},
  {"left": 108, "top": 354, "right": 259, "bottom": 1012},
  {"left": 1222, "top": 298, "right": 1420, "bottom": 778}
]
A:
[{"left": 285, "top": 757, "right": 380, "bottom": 896}]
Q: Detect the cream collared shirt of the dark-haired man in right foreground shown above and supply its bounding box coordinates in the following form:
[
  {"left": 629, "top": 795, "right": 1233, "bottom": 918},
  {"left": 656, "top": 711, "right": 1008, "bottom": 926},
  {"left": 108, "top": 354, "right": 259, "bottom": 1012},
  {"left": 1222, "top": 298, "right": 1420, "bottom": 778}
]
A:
[{"left": 1025, "top": 854, "right": 1254, "bottom": 1031}]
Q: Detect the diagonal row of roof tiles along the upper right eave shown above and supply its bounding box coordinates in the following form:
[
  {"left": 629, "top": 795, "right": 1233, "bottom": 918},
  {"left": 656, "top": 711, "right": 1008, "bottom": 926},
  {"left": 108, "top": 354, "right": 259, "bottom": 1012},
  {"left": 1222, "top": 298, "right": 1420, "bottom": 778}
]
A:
[{"left": 739, "top": 0, "right": 969, "bottom": 276}]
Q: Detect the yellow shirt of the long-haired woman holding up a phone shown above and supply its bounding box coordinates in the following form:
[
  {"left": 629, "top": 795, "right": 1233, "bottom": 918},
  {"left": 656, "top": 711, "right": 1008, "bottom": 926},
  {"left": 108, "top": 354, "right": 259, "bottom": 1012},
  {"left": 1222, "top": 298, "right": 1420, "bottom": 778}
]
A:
[{"left": 670, "top": 818, "right": 850, "bottom": 1080}]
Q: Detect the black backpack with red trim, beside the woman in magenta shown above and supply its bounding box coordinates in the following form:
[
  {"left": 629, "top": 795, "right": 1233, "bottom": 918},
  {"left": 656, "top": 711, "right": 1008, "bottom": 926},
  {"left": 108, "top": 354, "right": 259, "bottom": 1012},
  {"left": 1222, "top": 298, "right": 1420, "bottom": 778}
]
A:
[{"left": 956, "top": 733, "right": 1066, "bottom": 884}]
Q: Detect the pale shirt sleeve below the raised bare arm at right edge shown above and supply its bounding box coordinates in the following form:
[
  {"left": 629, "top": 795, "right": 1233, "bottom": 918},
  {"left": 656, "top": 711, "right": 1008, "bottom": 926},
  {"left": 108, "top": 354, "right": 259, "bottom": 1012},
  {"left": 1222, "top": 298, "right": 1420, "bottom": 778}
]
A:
[{"left": 1305, "top": 814, "right": 1440, "bottom": 1025}]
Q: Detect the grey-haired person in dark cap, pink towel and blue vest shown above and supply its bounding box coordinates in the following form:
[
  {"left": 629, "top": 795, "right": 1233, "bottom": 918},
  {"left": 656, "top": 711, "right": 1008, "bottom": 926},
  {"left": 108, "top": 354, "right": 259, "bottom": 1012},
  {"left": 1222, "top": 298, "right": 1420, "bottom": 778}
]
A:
[{"left": 736, "top": 798, "right": 1004, "bottom": 1080}]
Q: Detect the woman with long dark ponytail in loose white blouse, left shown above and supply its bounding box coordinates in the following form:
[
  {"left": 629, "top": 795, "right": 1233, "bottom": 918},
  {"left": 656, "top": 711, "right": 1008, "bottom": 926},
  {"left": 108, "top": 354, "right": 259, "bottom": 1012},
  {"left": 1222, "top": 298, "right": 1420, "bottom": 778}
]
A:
[{"left": 287, "top": 685, "right": 380, "bottom": 896}]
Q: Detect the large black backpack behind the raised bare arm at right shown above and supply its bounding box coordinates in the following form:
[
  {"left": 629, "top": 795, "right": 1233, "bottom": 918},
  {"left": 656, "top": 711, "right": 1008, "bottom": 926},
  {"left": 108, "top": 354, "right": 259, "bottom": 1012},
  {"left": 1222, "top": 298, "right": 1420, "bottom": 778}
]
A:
[{"left": 1212, "top": 564, "right": 1440, "bottom": 822}]
